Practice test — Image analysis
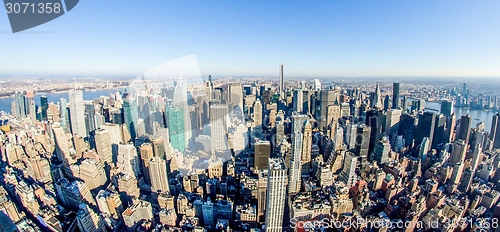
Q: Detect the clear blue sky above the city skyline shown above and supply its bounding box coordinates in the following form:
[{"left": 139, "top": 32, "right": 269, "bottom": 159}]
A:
[{"left": 0, "top": 0, "right": 500, "bottom": 77}]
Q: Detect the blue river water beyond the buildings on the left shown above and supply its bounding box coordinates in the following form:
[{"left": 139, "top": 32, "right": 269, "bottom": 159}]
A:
[{"left": 0, "top": 88, "right": 124, "bottom": 113}]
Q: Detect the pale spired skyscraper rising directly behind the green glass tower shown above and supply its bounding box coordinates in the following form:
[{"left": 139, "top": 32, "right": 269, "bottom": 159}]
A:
[{"left": 173, "top": 80, "right": 192, "bottom": 146}]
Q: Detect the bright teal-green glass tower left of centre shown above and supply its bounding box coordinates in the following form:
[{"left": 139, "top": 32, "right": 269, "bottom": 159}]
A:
[{"left": 166, "top": 107, "right": 189, "bottom": 152}]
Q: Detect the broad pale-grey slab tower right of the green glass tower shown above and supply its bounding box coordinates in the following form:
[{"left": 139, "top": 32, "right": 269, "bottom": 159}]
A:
[{"left": 210, "top": 103, "right": 229, "bottom": 151}]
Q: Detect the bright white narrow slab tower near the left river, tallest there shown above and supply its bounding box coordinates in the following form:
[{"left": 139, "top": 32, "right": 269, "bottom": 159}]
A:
[{"left": 69, "top": 89, "right": 87, "bottom": 138}]
